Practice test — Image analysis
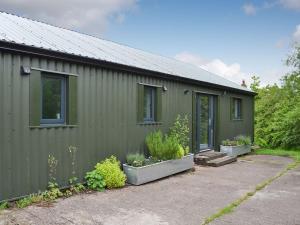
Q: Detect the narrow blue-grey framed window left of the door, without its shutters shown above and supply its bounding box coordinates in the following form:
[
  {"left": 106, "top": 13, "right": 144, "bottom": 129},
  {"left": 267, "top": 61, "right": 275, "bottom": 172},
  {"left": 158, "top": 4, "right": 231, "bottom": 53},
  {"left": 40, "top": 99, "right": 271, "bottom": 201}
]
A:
[{"left": 144, "top": 86, "right": 156, "bottom": 122}]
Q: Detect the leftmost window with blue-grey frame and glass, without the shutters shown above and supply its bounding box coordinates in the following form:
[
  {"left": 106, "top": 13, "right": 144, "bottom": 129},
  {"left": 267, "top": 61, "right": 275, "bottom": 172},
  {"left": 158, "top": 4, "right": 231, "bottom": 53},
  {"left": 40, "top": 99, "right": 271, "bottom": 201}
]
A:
[{"left": 41, "top": 75, "right": 66, "bottom": 124}]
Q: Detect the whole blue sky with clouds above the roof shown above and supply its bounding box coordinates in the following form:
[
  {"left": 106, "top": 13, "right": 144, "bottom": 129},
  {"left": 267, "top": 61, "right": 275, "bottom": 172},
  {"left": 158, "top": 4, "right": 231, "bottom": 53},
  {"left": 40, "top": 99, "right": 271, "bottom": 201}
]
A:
[{"left": 0, "top": 0, "right": 300, "bottom": 85}]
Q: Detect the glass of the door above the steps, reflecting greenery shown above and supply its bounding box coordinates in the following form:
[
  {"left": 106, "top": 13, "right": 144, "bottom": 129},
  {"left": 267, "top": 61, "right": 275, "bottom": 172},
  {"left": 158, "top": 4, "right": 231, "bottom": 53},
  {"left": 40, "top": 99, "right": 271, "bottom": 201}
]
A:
[{"left": 196, "top": 94, "right": 215, "bottom": 151}]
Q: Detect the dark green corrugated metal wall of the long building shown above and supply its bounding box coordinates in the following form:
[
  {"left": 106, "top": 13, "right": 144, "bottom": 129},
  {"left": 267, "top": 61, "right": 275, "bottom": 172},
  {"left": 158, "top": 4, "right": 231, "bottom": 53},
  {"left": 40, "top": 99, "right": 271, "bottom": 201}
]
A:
[{"left": 0, "top": 52, "right": 253, "bottom": 201}]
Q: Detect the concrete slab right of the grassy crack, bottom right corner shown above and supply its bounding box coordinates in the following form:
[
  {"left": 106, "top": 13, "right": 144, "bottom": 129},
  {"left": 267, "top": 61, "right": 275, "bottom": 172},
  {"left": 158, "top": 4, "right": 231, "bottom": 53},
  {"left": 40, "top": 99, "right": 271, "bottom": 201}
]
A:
[{"left": 211, "top": 167, "right": 300, "bottom": 225}]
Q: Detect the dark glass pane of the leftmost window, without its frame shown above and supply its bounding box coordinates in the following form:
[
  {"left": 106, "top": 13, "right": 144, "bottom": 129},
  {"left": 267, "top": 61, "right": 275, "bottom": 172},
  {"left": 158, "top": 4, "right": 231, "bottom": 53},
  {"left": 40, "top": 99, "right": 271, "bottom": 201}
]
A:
[{"left": 42, "top": 77, "right": 63, "bottom": 120}]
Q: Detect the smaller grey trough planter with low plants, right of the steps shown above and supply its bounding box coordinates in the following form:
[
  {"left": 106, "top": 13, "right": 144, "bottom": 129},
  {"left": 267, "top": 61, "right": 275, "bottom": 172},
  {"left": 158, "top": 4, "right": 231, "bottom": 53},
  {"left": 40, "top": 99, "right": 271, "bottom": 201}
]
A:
[{"left": 220, "top": 135, "right": 251, "bottom": 156}]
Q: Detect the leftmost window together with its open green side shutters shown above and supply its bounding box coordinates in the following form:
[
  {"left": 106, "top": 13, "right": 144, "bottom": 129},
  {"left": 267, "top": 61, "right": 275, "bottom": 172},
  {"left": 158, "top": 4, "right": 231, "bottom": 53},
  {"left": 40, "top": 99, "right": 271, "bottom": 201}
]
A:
[{"left": 29, "top": 69, "right": 78, "bottom": 128}]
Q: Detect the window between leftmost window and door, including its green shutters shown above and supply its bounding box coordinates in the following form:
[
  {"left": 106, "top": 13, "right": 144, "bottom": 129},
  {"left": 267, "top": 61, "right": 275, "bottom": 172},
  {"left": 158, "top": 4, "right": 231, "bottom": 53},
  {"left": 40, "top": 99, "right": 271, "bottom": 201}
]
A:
[{"left": 137, "top": 83, "right": 162, "bottom": 124}]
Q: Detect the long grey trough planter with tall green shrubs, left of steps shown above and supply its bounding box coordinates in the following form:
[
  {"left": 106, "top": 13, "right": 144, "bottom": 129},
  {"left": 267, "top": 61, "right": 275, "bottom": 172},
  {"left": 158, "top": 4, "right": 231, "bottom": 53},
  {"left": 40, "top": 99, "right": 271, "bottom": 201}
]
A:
[{"left": 123, "top": 116, "right": 194, "bottom": 185}]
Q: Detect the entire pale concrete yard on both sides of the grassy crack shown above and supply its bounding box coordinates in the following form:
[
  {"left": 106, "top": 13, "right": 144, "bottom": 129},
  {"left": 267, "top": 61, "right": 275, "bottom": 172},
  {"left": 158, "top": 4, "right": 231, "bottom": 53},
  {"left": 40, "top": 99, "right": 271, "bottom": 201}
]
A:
[{"left": 0, "top": 155, "right": 300, "bottom": 225}]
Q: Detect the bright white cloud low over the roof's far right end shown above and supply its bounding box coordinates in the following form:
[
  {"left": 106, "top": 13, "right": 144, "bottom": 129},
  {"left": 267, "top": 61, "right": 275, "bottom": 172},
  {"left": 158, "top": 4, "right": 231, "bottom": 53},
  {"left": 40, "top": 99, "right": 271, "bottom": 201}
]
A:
[{"left": 175, "top": 52, "right": 251, "bottom": 86}]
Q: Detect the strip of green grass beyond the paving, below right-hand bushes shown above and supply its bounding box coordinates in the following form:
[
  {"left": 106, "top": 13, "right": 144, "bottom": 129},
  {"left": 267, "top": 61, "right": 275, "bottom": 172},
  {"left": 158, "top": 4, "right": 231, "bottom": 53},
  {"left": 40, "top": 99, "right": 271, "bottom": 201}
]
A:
[{"left": 254, "top": 148, "right": 300, "bottom": 163}]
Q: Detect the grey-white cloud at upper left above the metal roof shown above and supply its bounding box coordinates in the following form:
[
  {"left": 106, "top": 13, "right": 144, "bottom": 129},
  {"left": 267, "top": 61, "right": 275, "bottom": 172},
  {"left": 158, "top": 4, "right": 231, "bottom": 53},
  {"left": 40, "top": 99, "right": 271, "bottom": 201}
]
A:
[{"left": 0, "top": 0, "right": 137, "bottom": 35}]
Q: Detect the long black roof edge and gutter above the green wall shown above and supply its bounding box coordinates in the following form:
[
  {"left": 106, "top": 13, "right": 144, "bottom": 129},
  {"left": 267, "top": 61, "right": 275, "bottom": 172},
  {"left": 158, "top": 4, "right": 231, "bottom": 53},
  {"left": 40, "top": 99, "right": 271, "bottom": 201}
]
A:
[{"left": 0, "top": 40, "right": 257, "bottom": 96}]
